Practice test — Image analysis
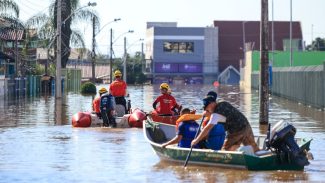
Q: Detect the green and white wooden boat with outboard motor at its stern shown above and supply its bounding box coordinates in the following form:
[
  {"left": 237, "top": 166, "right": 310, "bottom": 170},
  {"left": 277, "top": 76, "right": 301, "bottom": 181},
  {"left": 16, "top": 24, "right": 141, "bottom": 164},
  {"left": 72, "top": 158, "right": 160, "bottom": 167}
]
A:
[{"left": 143, "top": 120, "right": 312, "bottom": 170}]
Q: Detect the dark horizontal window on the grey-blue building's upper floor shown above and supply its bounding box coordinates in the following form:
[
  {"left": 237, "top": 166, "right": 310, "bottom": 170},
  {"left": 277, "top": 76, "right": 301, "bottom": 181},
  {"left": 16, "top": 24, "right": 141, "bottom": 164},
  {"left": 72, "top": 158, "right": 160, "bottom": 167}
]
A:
[{"left": 163, "top": 42, "right": 194, "bottom": 53}]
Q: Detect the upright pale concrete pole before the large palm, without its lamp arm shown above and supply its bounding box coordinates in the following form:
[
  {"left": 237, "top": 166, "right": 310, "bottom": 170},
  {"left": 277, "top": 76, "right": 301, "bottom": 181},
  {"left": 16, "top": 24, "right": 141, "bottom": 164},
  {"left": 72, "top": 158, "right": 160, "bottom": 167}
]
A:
[{"left": 55, "top": 0, "right": 62, "bottom": 98}]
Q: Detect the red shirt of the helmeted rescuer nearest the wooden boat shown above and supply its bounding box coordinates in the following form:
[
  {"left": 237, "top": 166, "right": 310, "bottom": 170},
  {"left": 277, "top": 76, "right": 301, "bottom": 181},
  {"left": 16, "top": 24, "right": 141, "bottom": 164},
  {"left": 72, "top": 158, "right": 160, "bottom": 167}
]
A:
[{"left": 154, "top": 94, "right": 176, "bottom": 114}]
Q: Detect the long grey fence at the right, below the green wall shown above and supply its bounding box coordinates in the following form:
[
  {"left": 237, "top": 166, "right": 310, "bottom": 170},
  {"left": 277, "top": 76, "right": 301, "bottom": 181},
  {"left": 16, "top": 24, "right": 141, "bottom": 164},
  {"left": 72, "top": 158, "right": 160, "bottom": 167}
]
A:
[{"left": 252, "top": 62, "right": 325, "bottom": 109}]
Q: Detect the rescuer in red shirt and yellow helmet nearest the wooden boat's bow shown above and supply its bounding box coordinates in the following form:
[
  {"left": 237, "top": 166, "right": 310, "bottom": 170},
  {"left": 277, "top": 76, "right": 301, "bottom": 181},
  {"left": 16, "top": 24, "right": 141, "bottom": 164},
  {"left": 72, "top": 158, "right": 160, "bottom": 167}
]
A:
[{"left": 152, "top": 83, "right": 179, "bottom": 116}]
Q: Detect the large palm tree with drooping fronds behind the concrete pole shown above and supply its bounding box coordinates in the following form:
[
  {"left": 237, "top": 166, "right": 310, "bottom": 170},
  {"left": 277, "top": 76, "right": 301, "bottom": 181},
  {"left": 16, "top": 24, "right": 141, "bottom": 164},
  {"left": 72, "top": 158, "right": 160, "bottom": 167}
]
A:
[{"left": 26, "top": 0, "right": 99, "bottom": 68}]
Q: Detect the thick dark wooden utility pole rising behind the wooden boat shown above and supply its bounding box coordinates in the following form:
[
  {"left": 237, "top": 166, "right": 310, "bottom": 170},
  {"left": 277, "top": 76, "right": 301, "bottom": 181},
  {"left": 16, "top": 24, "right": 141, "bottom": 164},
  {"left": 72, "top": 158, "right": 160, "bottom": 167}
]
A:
[{"left": 259, "top": 0, "right": 269, "bottom": 124}]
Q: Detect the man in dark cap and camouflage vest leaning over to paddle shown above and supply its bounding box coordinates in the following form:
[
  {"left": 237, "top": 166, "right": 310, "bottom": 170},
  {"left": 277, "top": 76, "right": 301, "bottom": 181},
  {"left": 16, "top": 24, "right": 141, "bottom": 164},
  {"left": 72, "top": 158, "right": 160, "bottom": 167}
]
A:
[{"left": 191, "top": 91, "right": 259, "bottom": 152}]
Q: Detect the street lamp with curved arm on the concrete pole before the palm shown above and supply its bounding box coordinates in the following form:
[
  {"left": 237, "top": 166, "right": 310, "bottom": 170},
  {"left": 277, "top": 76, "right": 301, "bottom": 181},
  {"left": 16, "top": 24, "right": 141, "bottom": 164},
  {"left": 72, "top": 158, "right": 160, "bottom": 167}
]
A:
[{"left": 55, "top": 0, "right": 97, "bottom": 98}]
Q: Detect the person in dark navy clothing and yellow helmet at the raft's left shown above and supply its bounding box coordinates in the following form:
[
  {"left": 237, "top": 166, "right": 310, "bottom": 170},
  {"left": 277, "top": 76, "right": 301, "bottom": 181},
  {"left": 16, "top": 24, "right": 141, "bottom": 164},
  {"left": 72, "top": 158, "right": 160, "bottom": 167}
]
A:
[{"left": 100, "top": 88, "right": 116, "bottom": 127}]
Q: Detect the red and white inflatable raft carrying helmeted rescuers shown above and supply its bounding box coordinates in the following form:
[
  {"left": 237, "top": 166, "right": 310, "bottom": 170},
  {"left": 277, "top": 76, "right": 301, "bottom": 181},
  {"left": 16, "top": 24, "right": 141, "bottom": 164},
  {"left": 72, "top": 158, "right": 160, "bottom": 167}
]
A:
[{"left": 71, "top": 105, "right": 146, "bottom": 128}]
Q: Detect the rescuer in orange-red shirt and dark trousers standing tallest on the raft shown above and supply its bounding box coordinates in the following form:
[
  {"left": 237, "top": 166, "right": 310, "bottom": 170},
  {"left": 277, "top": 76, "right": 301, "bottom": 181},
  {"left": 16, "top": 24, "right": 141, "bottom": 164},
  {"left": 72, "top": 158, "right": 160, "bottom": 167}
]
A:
[{"left": 109, "top": 70, "right": 128, "bottom": 114}]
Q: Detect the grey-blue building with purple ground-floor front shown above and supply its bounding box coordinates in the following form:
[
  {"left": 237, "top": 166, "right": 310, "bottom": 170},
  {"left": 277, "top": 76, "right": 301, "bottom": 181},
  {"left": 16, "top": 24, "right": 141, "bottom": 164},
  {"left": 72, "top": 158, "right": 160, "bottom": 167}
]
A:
[{"left": 144, "top": 22, "right": 219, "bottom": 84}]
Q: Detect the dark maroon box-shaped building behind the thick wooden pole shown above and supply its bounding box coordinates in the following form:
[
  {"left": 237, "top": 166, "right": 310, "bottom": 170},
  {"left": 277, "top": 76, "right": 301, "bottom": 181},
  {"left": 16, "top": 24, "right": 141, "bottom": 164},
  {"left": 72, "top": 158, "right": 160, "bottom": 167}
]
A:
[{"left": 214, "top": 20, "right": 303, "bottom": 72}]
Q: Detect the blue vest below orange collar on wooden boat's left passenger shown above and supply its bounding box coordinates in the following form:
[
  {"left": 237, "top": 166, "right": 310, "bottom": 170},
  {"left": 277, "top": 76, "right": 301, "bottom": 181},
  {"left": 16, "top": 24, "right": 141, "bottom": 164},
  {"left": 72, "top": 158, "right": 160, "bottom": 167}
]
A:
[{"left": 177, "top": 120, "right": 199, "bottom": 148}]
